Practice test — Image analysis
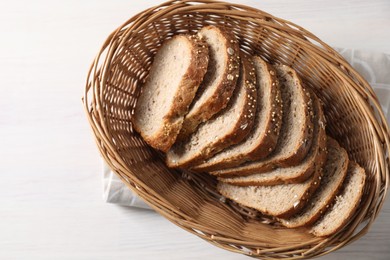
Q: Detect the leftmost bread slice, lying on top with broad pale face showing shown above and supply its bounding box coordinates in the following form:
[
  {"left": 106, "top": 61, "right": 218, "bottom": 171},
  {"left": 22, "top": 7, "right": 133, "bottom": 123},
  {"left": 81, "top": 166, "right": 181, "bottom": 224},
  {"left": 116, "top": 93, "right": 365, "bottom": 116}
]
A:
[{"left": 132, "top": 35, "right": 208, "bottom": 152}]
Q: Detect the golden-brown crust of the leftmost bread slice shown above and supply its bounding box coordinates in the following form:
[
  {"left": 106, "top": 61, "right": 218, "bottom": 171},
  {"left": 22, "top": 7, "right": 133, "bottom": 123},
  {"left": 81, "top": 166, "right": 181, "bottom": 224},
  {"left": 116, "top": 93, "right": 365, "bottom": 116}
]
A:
[{"left": 132, "top": 35, "right": 209, "bottom": 152}]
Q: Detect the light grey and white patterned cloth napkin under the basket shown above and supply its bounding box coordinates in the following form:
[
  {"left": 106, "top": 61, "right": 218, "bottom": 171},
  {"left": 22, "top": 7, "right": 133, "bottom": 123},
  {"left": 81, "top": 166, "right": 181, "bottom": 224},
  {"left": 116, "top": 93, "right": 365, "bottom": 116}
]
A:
[{"left": 103, "top": 48, "right": 390, "bottom": 209}]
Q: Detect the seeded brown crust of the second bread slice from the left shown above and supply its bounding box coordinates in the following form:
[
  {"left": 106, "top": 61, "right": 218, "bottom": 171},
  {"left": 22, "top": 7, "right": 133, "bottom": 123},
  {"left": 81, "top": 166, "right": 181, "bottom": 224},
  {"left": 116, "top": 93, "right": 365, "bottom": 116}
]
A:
[{"left": 177, "top": 26, "right": 240, "bottom": 140}]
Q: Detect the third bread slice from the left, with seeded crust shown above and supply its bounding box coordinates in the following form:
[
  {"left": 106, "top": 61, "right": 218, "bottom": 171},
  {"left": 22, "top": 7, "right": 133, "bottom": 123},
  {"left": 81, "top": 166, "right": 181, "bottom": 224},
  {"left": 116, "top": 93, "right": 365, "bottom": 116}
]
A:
[{"left": 166, "top": 56, "right": 257, "bottom": 168}]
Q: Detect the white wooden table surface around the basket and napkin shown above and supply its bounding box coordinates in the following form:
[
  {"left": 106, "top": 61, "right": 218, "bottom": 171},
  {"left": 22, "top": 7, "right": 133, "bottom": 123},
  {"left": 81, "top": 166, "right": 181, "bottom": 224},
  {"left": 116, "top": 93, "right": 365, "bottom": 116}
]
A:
[{"left": 0, "top": 0, "right": 390, "bottom": 260}]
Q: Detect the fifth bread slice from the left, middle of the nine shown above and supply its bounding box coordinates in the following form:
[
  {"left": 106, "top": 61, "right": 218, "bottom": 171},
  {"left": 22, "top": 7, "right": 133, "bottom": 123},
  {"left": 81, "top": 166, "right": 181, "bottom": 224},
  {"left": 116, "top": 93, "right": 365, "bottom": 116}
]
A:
[{"left": 211, "top": 65, "right": 314, "bottom": 176}]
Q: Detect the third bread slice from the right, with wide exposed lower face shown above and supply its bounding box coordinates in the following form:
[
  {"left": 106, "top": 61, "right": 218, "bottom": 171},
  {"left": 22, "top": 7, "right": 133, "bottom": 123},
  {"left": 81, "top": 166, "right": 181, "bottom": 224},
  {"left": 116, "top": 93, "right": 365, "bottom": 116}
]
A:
[{"left": 217, "top": 152, "right": 323, "bottom": 218}]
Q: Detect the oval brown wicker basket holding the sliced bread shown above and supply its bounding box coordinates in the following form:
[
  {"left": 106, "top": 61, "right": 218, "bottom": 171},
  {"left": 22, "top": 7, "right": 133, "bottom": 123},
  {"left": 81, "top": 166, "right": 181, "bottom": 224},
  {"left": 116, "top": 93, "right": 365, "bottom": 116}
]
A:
[{"left": 84, "top": 0, "right": 389, "bottom": 259}]
